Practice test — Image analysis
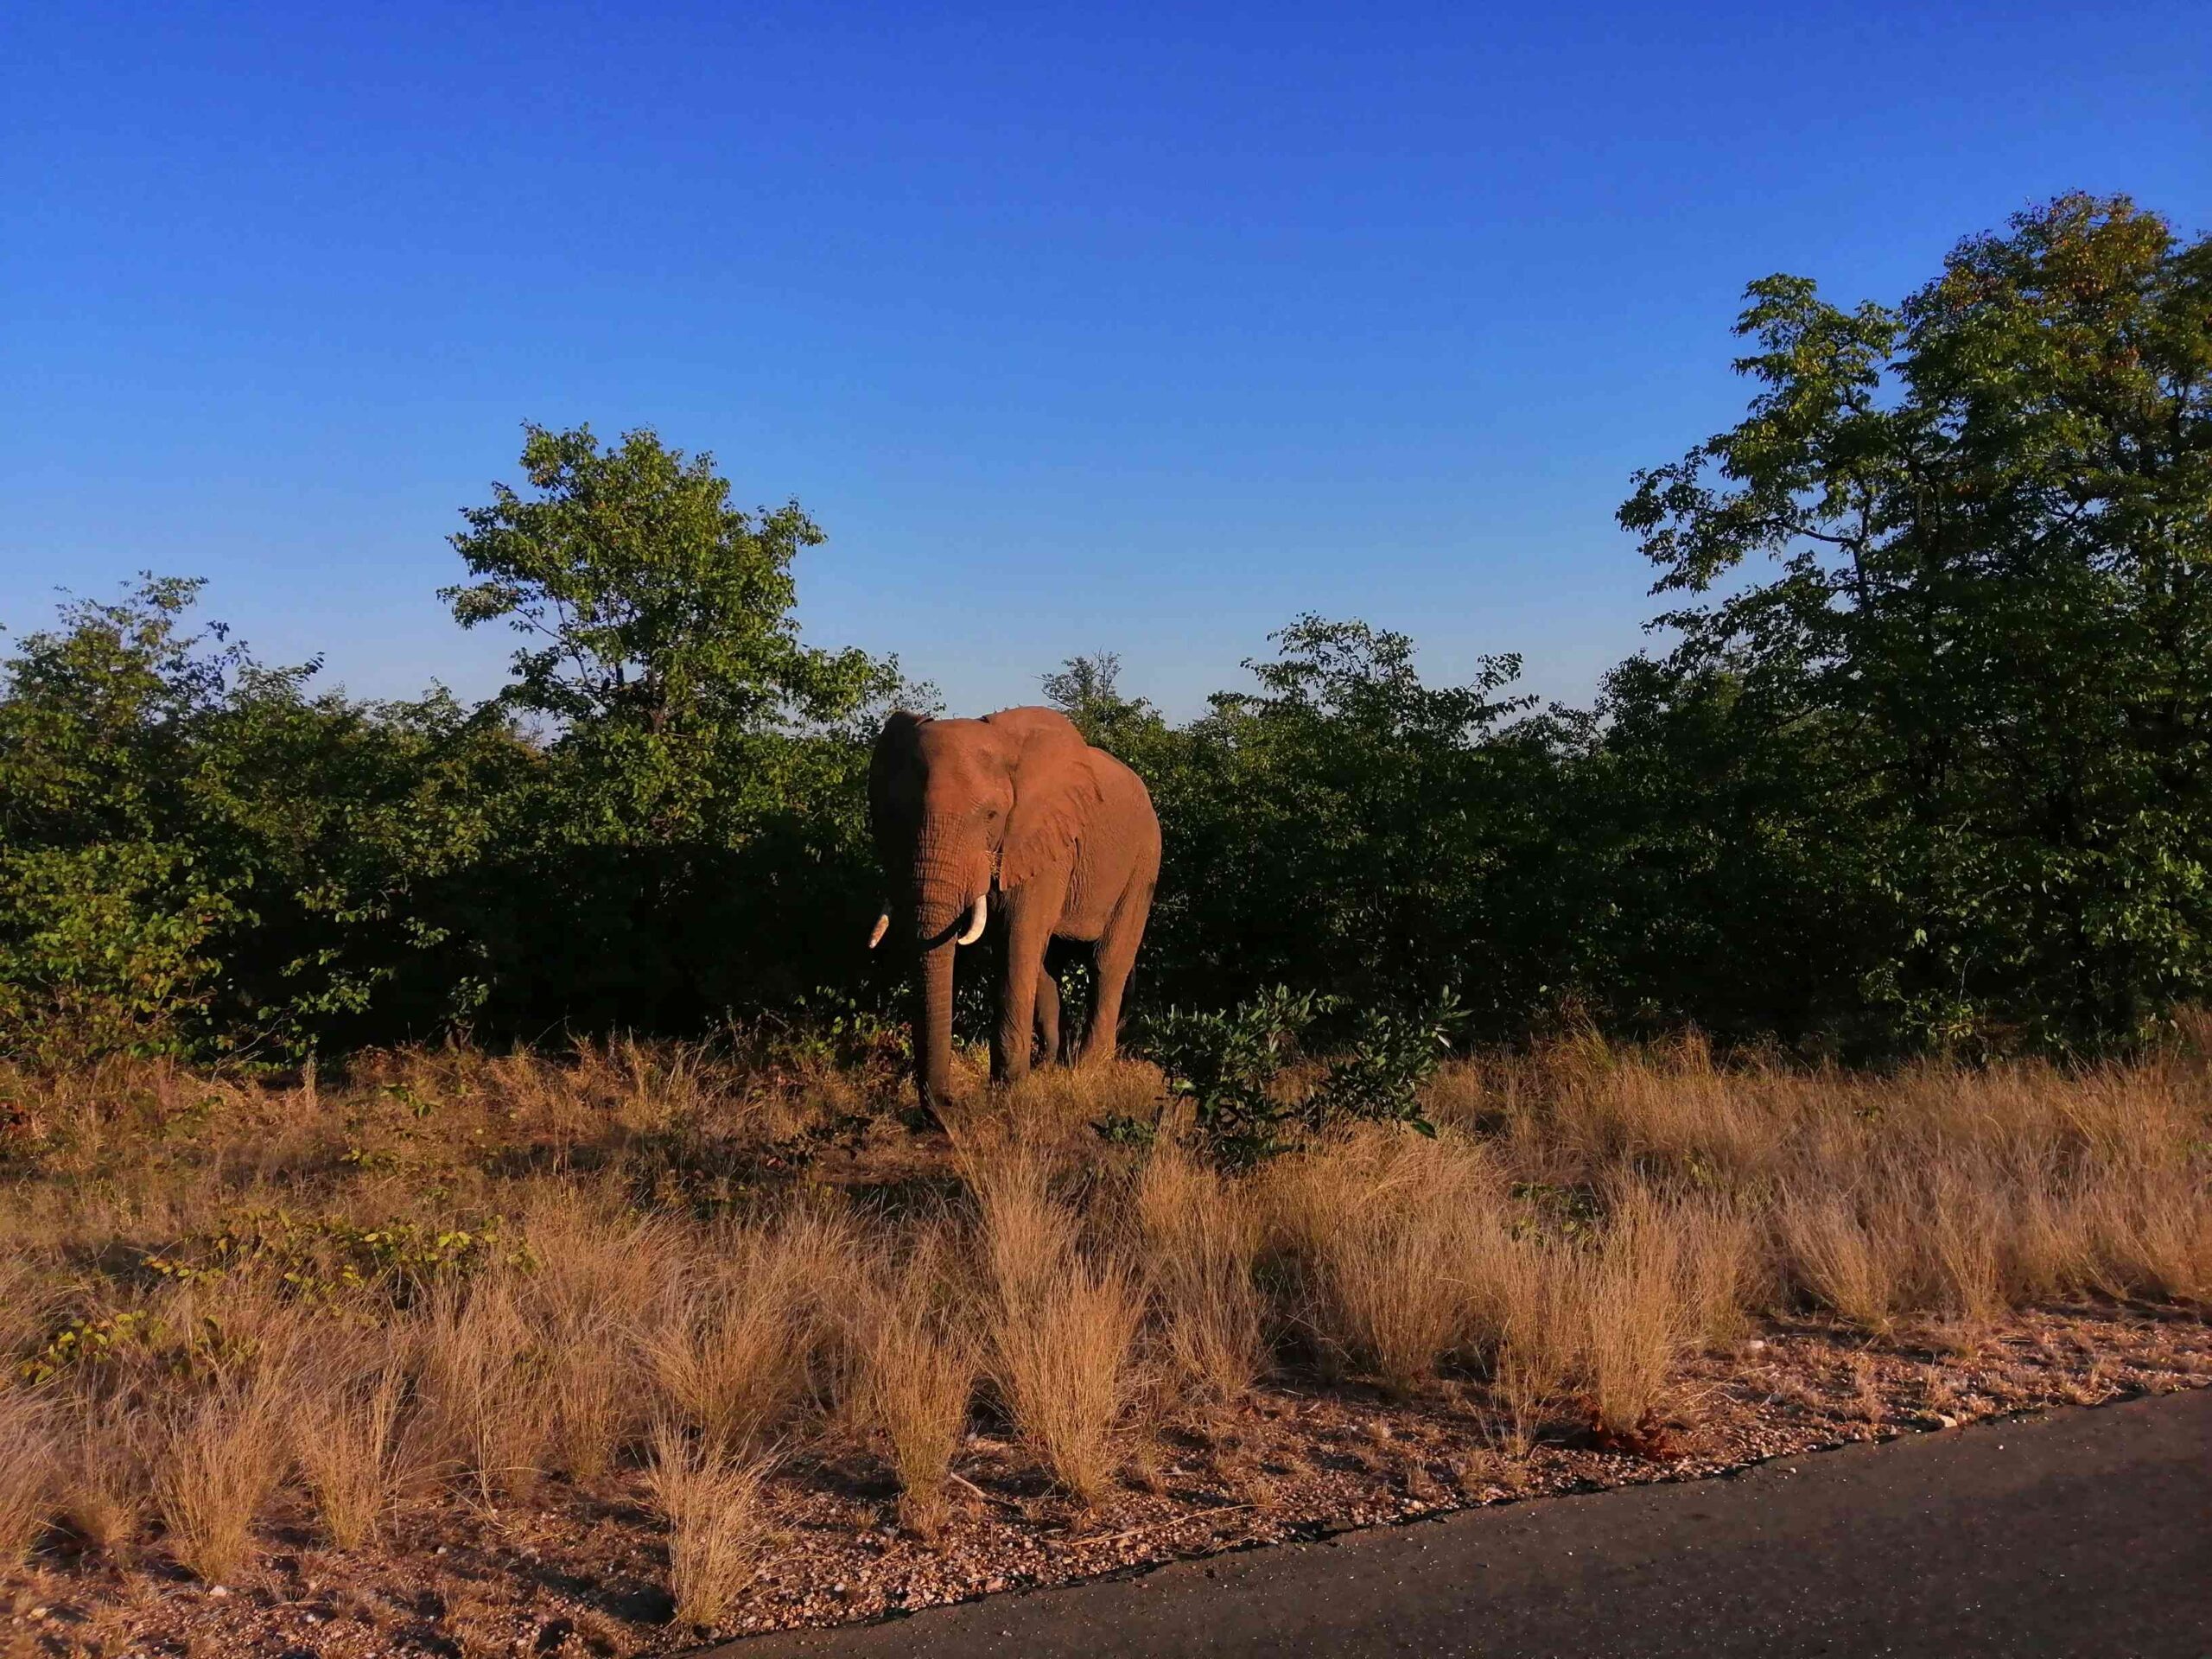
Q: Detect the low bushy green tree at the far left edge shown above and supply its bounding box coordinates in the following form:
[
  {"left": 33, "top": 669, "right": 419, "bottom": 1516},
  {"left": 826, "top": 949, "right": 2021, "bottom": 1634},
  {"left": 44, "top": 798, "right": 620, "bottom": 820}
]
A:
[{"left": 0, "top": 577, "right": 524, "bottom": 1058}]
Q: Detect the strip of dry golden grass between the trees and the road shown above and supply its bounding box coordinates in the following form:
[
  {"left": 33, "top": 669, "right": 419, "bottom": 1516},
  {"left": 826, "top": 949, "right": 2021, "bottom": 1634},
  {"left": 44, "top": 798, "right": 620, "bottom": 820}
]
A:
[{"left": 0, "top": 1035, "right": 2212, "bottom": 1626}]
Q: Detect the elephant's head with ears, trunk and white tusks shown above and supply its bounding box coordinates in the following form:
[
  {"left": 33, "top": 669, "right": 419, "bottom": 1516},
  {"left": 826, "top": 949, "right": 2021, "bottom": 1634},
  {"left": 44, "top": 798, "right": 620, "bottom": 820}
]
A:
[{"left": 868, "top": 708, "right": 1099, "bottom": 1103}]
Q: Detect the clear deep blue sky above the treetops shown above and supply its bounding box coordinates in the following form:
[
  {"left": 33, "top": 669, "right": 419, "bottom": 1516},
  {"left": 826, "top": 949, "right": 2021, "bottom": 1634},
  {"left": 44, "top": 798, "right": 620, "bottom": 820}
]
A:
[{"left": 0, "top": 0, "right": 2212, "bottom": 712}]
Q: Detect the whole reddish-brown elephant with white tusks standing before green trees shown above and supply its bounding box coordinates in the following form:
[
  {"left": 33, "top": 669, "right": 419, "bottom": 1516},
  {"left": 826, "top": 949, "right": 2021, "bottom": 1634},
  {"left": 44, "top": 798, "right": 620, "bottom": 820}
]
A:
[{"left": 868, "top": 708, "right": 1159, "bottom": 1117}]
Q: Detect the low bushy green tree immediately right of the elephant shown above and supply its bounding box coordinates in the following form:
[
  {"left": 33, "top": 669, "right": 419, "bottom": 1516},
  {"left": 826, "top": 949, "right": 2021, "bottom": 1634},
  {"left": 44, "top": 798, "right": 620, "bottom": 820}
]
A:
[{"left": 1115, "top": 617, "right": 1553, "bottom": 1022}]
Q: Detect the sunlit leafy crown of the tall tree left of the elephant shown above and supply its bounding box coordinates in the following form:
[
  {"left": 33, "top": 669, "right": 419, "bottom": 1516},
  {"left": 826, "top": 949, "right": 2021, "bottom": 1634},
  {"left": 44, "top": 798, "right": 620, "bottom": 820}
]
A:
[{"left": 440, "top": 425, "right": 900, "bottom": 841}]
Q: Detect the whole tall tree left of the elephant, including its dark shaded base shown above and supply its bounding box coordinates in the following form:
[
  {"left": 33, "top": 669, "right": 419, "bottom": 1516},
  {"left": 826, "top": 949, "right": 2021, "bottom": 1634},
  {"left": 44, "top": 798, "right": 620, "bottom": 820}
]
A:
[{"left": 445, "top": 427, "right": 916, "bottom": 1027}]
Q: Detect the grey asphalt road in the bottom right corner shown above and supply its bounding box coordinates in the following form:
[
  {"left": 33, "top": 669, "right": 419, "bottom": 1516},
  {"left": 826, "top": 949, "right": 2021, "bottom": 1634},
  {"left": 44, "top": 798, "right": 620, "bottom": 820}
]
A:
[{"left": 716, "top": 1389, "right": 2212, "bottom": 1659}]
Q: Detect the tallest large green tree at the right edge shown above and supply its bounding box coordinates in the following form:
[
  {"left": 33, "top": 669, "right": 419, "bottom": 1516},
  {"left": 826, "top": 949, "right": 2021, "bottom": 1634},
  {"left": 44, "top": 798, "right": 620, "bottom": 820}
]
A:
[{"left": 1621, "top": 194, "right": 2212, "bottom": 1042}]
